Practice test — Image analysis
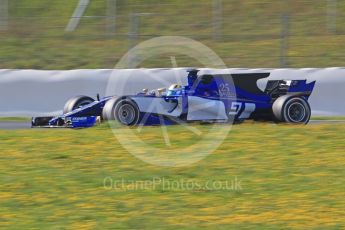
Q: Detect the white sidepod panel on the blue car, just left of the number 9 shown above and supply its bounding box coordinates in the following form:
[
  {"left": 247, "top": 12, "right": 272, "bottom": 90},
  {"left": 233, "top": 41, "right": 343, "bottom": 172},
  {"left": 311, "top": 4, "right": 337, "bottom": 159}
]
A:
[{"left": 187, "top": 96, "right": 228, "bottom": 121}]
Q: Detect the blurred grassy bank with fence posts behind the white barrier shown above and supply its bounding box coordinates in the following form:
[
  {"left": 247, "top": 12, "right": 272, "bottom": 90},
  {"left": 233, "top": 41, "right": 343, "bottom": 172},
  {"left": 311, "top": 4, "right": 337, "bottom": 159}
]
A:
[{"left": 0, "top": 0, "right": 345, "bottom": 69}]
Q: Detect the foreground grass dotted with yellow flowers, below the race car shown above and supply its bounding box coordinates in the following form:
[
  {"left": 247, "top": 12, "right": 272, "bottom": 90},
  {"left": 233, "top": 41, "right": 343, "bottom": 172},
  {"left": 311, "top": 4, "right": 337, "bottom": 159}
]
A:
[{"left": 0, "top": 123, "right": 345, "bottom": 229}]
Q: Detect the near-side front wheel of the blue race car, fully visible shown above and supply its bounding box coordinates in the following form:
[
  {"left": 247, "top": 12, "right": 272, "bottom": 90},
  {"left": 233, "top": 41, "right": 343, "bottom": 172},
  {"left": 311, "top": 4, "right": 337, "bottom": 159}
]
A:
[{"left": 102, "top": 98, "right": 140, "bottom": 126}]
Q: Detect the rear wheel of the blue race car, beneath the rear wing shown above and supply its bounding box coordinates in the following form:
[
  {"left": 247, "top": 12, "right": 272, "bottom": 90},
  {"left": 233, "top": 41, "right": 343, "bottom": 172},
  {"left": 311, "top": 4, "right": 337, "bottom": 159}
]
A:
[{"left": 272, "top": 95, "right": 311, "bottom": 124}]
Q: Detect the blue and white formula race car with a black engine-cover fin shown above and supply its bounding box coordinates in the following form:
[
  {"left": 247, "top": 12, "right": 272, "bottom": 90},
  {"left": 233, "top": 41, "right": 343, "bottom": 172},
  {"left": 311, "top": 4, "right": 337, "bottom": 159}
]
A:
[{"left": 32, "top": 69, "right": 315, "bottom": 128}]
